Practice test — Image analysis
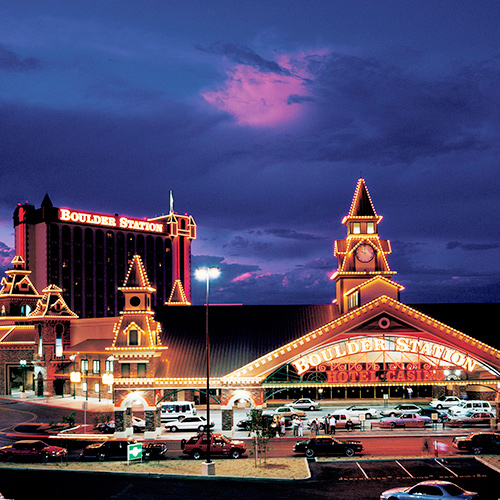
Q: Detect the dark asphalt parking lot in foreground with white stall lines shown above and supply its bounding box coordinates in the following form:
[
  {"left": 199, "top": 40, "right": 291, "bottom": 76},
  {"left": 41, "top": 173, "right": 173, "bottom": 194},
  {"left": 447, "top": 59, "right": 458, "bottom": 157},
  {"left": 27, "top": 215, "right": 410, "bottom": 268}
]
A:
[{"left": 0, "top": 458, "right": 500, "bottom": 500}]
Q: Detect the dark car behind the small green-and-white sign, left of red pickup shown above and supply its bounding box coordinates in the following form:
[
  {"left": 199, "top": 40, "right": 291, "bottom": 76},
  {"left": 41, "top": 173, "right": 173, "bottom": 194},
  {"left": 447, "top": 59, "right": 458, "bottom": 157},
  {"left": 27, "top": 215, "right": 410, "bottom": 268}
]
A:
[{"left": 80, "top": 438, "right": 168, "bottom": 461}]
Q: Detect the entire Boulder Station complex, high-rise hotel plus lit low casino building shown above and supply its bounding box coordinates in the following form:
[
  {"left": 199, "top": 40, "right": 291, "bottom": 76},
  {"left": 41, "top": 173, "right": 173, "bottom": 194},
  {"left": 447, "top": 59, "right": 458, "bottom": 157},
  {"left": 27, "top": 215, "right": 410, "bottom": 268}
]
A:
[{"left": 0, "top": 179, "right": 500, "bottom": 437}]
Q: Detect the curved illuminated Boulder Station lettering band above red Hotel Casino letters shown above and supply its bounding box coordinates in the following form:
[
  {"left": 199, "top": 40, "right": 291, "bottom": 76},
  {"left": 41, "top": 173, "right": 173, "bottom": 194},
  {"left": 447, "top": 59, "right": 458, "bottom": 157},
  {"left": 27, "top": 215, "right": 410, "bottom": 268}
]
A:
[{"left": 292, "top": 337, "right": 476, "bottom": 375}]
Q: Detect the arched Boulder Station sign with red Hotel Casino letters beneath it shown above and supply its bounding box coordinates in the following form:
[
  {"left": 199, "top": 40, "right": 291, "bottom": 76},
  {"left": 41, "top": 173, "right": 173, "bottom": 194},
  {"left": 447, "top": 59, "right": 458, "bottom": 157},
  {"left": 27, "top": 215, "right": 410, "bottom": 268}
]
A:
[{"left": 291, "top": 337, "right": 476, "bottom": 376}]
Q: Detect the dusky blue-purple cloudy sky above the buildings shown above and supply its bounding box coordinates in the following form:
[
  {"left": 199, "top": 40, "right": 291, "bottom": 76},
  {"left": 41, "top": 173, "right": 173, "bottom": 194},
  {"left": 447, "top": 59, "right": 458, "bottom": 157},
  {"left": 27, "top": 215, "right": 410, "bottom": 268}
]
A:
[{"left": 0, "top": 0, "right": 500, "bottom": 304}]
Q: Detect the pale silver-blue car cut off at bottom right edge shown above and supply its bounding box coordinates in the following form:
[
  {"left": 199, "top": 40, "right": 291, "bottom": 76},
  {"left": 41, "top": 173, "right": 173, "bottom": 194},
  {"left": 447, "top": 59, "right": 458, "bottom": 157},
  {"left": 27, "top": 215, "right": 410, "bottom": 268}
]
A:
[{"left": 380, "top": 480, "right": 479, "bottom": 500}]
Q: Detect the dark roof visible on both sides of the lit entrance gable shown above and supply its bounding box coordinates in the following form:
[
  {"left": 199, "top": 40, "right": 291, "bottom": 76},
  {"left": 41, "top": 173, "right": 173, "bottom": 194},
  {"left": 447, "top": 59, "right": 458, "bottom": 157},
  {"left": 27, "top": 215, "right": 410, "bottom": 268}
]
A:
[{"left": 155, "top": 302, "right": 500, "bottom": 377}]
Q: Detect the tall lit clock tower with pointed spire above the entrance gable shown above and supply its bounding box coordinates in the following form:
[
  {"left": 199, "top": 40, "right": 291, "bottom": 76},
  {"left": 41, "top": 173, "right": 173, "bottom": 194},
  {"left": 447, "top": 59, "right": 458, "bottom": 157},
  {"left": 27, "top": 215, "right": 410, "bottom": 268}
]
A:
[{"left": 331, "top": 179, "right": 402, "bottom": 313}]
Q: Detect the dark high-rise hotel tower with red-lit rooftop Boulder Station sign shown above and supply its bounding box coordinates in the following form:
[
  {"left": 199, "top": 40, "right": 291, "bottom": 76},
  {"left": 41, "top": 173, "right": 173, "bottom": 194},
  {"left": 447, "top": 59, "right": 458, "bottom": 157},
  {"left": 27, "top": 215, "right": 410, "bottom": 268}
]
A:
[{"left": 14, "top": 195, "right": 196, "bottom": 318}]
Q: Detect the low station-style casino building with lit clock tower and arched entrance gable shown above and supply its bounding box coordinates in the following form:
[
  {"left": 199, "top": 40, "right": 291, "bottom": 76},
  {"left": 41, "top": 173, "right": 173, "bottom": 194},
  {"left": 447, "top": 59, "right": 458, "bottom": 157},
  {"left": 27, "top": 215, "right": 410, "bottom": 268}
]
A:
[{"left": 0, "top": 179, "right": 500, "bottom": 437}]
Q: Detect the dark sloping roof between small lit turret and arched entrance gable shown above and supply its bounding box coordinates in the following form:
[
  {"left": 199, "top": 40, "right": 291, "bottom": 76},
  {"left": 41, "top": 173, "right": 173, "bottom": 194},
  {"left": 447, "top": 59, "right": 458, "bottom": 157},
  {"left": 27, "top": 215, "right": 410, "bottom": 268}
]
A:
[{"left": 155, "top": 304, "right": 338, "bottom": 377}]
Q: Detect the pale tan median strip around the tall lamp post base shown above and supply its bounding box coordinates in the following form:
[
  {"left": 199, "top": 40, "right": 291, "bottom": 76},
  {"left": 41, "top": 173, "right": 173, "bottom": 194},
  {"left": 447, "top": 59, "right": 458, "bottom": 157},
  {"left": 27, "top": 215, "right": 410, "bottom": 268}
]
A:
[{"left": 0, "top": 458, "right": 310, "bottom": 479}]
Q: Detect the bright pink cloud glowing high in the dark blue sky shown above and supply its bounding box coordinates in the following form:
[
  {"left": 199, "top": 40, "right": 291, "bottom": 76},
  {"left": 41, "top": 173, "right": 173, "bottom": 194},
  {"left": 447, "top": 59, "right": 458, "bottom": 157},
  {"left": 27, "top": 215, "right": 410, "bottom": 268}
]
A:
[{"left": 201, "top": 51, "right": 311, "bottom": 127}]
